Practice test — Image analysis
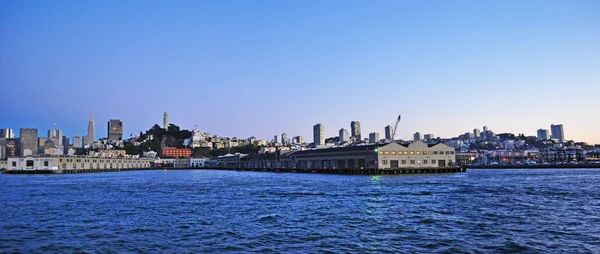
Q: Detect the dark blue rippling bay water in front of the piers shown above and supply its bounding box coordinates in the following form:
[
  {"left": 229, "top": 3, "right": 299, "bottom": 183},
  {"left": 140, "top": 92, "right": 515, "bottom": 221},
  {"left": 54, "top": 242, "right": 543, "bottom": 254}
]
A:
[{"left": 0, "top": 169, "right": 600, "bottom": 253}]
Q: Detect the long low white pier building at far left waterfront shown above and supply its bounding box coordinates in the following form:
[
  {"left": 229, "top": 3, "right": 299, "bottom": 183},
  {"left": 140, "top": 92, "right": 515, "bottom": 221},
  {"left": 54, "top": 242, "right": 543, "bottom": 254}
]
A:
[{"left": 7, "top": 156, "right": 152, "bottom": 171}]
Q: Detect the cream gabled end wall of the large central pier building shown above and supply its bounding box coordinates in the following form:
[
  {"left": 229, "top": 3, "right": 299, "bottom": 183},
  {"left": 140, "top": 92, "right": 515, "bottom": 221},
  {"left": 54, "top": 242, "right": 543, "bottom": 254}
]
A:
[{"left": 378, "top": 141, "right": 456, "bottom": 169}]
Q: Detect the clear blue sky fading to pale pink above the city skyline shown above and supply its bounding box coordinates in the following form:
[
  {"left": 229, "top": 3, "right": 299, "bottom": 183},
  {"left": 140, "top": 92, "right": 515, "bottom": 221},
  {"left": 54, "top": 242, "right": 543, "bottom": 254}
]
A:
[{"left": 0, "top": 0, "right": 600, "bottom": 144}]
